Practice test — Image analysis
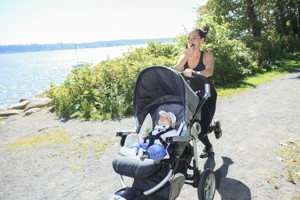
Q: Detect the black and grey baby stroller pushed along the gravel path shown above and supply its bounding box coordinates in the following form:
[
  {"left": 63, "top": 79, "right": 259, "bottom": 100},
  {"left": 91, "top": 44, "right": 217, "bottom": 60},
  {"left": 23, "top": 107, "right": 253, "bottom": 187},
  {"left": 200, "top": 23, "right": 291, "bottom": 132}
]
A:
[{"left": 110, "top": 66, "right": 216, "bottom": 200}]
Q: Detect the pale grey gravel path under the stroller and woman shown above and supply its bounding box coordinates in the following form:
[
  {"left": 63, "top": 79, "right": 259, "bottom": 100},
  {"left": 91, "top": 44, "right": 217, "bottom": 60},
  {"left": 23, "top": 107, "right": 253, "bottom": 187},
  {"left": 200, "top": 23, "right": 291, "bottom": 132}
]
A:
[{"left": 0, "top": 71, "right": 300, "bottom": 200}]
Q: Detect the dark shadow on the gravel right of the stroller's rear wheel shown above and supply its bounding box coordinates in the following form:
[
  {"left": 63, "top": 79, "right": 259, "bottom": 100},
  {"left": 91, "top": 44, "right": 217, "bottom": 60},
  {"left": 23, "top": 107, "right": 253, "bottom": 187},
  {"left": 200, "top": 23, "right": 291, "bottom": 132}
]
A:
[{"left": 204, "top": 155, "right": 251, "bottom": 200}]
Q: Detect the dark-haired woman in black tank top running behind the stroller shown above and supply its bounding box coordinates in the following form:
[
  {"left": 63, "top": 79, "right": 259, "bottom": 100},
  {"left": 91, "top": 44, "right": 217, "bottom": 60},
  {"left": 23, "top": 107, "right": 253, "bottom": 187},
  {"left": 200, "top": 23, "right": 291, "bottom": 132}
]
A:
[{"left": 174, "top": 28, "right": 222, "bottom": 158}]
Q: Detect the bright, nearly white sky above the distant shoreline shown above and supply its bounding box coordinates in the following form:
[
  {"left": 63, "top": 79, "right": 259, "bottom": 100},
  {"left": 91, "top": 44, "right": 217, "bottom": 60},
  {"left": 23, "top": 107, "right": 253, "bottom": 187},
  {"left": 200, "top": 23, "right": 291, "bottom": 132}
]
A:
[{"left": 0, "top": 0, "right": 206, "bottom": 45}]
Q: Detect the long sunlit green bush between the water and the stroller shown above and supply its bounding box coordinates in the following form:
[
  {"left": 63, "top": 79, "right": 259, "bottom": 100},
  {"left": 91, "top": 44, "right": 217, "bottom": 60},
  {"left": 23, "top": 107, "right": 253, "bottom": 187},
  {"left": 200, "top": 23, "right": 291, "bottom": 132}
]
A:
[{"left": 45, "top": 42, "right": 178, "bottom": 120}]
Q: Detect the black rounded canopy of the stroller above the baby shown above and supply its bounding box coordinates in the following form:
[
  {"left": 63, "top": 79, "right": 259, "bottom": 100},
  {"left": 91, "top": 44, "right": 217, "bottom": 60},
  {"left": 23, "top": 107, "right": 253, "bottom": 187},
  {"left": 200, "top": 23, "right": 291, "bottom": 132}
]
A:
[{"left": 133, "top": 66, "right": 199, "bottom": 125}]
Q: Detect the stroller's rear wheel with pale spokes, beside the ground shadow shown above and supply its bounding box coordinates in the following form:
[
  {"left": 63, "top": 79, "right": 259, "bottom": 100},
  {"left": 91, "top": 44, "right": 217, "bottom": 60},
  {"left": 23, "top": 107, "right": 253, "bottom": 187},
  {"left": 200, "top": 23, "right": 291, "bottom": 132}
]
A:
[{"left": 198, "top": 169, "right": 216, "bottom": 200}]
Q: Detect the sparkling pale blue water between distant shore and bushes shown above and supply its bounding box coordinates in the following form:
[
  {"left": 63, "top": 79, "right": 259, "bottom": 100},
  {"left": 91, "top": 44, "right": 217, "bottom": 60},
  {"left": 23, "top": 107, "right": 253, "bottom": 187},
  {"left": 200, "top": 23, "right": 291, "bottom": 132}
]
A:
[{"left": 0, "top": 45, "right": 145, "bottom": 106}]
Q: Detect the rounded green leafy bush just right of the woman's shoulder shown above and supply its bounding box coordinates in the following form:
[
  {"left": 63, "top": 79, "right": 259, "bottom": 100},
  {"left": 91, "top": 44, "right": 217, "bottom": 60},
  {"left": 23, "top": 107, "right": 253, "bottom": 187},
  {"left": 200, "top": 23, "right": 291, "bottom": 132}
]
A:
[{"left": 209, "top": 24, "right": 257, "bottom": 85}]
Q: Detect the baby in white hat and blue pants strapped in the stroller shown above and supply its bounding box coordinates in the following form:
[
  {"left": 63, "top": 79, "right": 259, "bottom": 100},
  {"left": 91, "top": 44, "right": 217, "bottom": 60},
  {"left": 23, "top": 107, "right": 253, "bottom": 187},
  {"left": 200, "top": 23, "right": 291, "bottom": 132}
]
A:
[{"left": 120, "top": 111, "right": 178, "bottom": 158}]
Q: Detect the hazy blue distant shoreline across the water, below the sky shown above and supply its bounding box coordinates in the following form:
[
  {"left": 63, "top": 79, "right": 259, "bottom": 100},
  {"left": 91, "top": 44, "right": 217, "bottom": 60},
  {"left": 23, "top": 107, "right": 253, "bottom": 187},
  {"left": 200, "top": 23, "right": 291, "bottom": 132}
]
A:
[{"left": 0, "top": 38, "right": 173, "bottom": 54}]
